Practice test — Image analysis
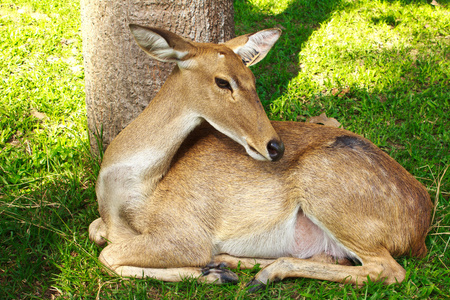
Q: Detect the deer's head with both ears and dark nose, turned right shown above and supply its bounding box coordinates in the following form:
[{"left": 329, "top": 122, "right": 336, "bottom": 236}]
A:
[{"left": 130, "top": 25, "right": 284, "bottom": 161}]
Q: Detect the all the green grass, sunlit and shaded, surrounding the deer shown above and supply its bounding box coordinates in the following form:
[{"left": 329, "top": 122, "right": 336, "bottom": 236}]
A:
[{"left": 0, "top": 0, "right": 450, "bottom": 299}]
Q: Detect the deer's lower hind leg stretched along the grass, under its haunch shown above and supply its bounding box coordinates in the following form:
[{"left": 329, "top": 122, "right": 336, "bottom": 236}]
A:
[{"left": 249, "top": 249, "right": 405, "bottom": 290}]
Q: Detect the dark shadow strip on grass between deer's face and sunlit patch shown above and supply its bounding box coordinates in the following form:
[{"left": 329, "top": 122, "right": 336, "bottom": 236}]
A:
[{"left": 234, "top": 0, "right": 341, "bottom": 107}]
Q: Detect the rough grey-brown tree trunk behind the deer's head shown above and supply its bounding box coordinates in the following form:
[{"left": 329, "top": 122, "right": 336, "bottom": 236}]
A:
[{"left": 81, "top": 0, "right": 234, "bottom": 154}]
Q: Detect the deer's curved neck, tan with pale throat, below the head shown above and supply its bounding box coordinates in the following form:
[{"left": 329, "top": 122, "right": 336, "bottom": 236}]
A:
[{"left": 102, "top": 71, "right": 201, "bottom": 190}]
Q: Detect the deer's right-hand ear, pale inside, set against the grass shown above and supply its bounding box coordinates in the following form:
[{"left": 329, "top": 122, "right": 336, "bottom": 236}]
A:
[{"left": 225, "top": 28, "right": 281, "bottom": 67}]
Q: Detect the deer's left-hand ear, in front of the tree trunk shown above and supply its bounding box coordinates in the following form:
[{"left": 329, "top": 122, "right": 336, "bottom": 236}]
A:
[{"left": 129, "top": 24, "right": 195, "bottom": 62}]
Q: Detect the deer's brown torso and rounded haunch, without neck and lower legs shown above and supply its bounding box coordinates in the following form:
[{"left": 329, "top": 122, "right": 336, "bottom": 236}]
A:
[{"left": 138, "top": 122, "right": 431, "bottom": 256}]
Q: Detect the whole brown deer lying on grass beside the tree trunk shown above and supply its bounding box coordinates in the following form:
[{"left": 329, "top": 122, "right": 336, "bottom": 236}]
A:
[{"left": 89, "top": 24, "right": 432, "bottom": 291}]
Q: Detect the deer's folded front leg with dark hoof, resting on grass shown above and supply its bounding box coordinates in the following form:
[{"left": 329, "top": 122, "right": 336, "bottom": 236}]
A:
[{"left": 99, "top": 234, "right": 238, "bottom": 284}]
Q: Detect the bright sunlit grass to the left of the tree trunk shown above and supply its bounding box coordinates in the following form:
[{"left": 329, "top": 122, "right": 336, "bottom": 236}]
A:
[{"left": 0, "top": 1, "right": 86, "bottom": 192}]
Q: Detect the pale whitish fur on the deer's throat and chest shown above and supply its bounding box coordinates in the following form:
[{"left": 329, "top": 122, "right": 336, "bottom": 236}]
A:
[{"left": 97, "top": 111, "right": 201, "bottom": 211}]
